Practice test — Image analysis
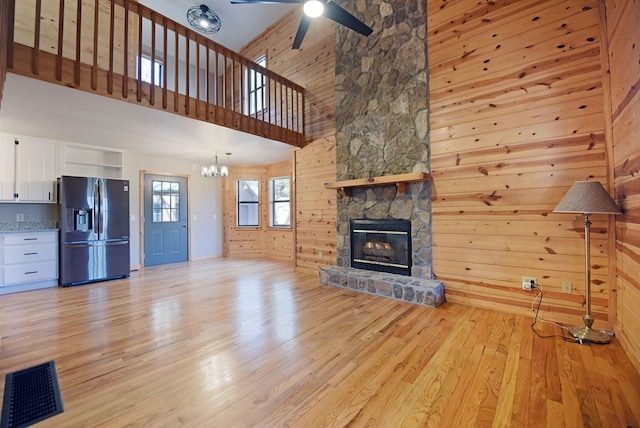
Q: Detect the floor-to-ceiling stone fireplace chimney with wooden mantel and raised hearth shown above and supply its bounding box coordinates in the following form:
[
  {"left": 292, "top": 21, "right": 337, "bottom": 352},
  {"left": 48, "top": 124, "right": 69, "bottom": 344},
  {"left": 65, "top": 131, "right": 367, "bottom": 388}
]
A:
[{"left": 320, "top": 0, "right": 444, "bottom": 306}]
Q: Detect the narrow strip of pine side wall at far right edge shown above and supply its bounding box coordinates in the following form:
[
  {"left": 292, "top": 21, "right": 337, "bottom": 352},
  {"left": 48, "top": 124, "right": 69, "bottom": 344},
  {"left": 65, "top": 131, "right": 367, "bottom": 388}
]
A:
[{"left": 605, "top": 0, "right": 640, "bottom": 370}]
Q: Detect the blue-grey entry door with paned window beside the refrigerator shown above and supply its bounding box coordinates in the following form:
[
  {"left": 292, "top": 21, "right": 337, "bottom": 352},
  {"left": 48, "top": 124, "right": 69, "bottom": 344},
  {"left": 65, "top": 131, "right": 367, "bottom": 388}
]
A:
[{"left": 140, "top": 171, "right": 190, "bottom": 266}]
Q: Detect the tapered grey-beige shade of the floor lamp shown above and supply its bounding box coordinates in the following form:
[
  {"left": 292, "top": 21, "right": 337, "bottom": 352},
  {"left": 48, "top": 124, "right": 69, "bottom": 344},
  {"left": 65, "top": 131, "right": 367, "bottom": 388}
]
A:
[{"left": 553, "top": 181, "right": 621, "bottom": 214}]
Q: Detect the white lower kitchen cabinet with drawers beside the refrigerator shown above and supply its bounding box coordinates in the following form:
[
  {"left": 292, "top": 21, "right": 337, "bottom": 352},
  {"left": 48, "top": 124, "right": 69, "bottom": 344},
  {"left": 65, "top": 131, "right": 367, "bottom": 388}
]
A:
[{"left": 0, "top": 231, "right": 58, "bottom": 294}]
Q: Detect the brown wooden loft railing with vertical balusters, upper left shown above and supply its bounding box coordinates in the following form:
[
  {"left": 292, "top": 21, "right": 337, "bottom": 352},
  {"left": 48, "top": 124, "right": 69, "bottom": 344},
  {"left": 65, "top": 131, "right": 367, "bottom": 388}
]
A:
[{"left": 0, "top": 0, "right": 307, "bottom": 147}]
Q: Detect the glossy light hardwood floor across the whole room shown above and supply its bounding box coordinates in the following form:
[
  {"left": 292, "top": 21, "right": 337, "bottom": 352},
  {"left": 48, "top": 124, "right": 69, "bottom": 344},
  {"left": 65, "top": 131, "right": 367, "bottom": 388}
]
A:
[{"left": 0, "top": 259, "right": 640, "bottom": 427}]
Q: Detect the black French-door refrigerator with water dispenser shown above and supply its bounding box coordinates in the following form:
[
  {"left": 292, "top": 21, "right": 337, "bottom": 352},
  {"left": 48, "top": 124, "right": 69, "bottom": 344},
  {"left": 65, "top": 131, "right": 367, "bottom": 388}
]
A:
[{"left": 58, "top": 176, "right": 130, "bottom": 287}]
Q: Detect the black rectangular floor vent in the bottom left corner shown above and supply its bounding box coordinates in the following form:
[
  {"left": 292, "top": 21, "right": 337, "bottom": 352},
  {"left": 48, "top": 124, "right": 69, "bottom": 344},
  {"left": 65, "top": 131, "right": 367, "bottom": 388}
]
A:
[{"left": 0, "top": 361, "right": 64, "bottom": 428}]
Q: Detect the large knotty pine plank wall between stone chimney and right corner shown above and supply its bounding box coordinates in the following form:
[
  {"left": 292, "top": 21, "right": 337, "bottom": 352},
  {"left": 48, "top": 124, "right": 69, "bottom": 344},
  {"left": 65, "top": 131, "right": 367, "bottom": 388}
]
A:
[{"left": 427, "top": 0, "right": 613, "bottom": 327}]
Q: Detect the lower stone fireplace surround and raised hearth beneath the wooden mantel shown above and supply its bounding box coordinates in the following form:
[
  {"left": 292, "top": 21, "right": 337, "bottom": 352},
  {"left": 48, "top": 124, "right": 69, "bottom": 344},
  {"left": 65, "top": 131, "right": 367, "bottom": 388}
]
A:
[{"left": 320, "top": 177, "right": 445, "bottom": 307}]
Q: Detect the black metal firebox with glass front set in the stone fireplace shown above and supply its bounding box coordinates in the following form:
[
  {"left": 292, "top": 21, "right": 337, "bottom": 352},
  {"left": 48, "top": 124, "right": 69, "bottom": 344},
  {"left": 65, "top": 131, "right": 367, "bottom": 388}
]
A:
[{"left": 349, "top": 219, "right": 411, "bottom": 276}]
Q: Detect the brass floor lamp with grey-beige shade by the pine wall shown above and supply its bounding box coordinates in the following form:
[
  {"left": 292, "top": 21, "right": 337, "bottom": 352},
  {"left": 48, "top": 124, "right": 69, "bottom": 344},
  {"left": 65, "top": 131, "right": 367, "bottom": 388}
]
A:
[{"left": 553, "top": 181, "right": 621, "bottom": 343}]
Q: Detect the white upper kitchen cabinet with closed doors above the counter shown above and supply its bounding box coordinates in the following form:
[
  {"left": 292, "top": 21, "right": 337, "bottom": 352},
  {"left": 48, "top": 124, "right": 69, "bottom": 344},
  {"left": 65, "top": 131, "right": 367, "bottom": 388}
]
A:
[{"left": 0, "top": 135, "right": 58, "bottom": 203}]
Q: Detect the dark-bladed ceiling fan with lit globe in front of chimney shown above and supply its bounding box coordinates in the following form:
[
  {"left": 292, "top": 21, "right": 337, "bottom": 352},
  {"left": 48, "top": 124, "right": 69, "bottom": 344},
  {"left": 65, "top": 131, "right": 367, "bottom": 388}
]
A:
[{"left": 231, "top": 0, "right": 373, "bottom": 49}]
